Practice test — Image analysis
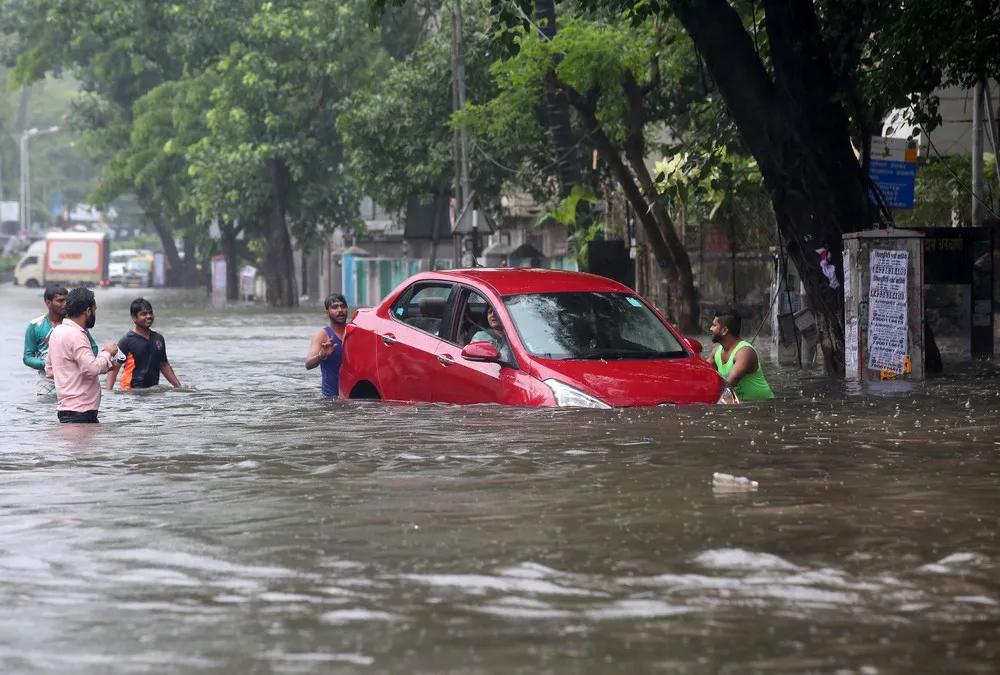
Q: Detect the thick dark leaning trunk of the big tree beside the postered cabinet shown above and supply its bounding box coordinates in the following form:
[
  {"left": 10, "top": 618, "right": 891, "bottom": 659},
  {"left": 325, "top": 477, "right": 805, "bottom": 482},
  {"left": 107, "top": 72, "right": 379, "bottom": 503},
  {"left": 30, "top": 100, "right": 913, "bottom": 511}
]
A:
[{"left": 670, "top": 0, "right": 867, "bottom": 374}]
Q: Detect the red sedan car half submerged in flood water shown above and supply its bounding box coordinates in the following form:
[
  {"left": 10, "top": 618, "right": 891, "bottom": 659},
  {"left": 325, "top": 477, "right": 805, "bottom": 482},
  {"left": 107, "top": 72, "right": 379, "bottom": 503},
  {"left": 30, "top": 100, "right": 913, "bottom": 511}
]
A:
[{"left": 340, "top": 268, "right": 731, "bottom": 408}]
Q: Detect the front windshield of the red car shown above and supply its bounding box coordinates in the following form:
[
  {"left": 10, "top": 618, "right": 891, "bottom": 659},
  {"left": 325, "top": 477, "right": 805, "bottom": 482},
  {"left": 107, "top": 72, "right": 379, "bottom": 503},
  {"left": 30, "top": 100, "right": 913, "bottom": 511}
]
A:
[{"left": 504, "top": 293, "right": 688, "bottom": 360}]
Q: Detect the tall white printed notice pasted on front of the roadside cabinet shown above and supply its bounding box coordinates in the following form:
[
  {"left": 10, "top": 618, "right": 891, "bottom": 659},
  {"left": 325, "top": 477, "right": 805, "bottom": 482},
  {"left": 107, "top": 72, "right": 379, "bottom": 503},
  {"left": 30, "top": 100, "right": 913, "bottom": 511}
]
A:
[{"left": 868, "top": 249, "right": 910, "bottom": 373}]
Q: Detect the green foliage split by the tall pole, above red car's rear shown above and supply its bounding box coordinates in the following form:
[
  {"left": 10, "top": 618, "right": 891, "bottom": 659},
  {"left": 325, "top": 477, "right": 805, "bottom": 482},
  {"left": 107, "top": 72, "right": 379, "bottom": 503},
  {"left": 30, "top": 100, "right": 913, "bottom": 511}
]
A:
[{"left": 337, "top": 4, "right": 549, "bottom": 211}]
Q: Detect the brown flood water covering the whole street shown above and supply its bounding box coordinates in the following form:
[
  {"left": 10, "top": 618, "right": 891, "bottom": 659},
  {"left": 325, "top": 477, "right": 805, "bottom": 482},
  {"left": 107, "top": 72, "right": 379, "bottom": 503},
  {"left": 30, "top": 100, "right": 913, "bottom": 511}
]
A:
[{"left": 0, "top": 285, "right": 1000, "bottom": 675}]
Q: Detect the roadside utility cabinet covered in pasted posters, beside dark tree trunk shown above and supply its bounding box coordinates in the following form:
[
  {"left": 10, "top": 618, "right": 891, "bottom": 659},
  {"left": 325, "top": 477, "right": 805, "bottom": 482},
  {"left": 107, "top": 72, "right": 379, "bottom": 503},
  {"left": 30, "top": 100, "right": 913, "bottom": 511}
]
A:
[{"left": 844, "top": 228, "right": 924, "bottom": 382}]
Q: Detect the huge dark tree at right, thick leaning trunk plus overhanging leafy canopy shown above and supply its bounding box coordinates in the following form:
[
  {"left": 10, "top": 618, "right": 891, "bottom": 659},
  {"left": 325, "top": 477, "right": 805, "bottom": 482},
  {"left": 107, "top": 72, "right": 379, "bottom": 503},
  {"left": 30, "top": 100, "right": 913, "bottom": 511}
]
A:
[{"left": 373, "top": 0, "right": 1000, "bottom": 373}]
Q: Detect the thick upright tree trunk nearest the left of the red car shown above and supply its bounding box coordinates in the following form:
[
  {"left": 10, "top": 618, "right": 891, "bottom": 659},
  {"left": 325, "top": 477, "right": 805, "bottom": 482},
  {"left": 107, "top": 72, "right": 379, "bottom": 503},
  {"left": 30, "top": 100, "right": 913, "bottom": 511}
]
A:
[{"left": 264, "top": 159, "right": 299, "bottom": 307}]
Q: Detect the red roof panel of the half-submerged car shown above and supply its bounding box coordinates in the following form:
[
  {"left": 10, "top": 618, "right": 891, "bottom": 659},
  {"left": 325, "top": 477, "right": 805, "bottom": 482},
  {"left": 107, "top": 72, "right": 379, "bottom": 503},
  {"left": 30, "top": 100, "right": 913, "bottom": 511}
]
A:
[{"left": 421, "top": 267, "right": 632, "bottom": 295}]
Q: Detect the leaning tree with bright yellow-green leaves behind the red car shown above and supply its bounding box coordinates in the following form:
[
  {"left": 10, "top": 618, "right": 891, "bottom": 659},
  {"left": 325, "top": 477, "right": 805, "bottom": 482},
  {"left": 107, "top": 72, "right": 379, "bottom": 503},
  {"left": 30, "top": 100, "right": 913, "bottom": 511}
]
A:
[{"left": 457, "top": 18, "right": 698, "bottom": 331}]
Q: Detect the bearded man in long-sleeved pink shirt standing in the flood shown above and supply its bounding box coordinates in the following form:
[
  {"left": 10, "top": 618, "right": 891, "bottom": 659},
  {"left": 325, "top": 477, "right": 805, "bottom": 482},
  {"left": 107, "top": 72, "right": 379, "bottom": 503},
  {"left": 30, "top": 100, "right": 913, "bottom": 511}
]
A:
[{"left": 45, "top": 288, "right": 118, "bottom": 423}]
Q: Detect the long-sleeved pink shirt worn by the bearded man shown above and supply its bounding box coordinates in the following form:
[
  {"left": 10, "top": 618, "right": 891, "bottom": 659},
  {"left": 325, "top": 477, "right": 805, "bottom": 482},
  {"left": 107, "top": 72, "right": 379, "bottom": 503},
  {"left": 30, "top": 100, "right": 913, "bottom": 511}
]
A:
[{"left": 45, "top": 319, "right": 111, "bottom": 412}]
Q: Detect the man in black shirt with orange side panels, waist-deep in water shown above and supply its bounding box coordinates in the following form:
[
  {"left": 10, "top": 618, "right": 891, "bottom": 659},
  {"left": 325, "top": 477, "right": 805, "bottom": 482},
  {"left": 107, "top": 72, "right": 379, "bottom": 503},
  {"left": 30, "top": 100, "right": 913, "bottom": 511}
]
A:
[{"left": 108, "top": 298, "right": 181, "bottom": 390}]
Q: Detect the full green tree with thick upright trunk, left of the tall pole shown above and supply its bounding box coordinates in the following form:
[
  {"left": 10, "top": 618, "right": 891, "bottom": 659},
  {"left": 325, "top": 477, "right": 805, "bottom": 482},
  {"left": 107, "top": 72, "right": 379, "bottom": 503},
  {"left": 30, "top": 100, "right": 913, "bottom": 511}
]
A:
[{"left": 190, "top": 0, "right": 384, "bottom": 307}]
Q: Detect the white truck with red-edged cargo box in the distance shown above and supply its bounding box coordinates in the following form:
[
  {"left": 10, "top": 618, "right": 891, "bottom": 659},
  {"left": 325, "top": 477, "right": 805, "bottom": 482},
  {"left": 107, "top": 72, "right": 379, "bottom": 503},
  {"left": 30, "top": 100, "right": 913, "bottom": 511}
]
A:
[{"left": 14, "top": 232, "right": 111, "bottom": 288}]
